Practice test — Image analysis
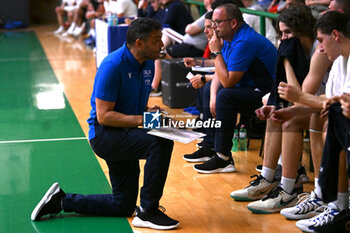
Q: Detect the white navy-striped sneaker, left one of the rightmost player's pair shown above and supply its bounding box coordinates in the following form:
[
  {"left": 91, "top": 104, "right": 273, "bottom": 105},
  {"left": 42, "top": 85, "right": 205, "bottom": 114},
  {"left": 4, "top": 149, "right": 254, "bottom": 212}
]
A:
[{"left": 281, "top": 191, "right": 326, "bottom": 220}]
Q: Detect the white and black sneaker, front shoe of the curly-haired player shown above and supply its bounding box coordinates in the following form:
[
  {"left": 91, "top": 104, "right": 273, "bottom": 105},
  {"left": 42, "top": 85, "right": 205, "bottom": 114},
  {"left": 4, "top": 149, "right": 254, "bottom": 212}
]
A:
[{"left": 247, "top": 186, "right": 297, "bottom": 214}]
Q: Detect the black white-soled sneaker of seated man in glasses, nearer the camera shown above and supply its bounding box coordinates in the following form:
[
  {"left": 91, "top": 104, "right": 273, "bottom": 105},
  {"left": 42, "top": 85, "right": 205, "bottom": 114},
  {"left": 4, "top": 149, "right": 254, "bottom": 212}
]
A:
[{"left": 193, "top": 153, "right": 236, "bottom": 174}]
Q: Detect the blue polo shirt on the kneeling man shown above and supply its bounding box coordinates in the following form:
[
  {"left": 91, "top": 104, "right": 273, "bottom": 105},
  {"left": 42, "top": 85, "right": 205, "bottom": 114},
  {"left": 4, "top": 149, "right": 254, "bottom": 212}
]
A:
[{"left": 87, "top": 44, "right": 154, "bottom": 140}]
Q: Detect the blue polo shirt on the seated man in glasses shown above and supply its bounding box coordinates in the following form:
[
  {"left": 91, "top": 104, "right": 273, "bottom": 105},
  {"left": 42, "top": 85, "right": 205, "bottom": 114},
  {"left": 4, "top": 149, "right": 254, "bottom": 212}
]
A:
[{"left": 221, "top": 23, "right": 277, "bottom": 91}]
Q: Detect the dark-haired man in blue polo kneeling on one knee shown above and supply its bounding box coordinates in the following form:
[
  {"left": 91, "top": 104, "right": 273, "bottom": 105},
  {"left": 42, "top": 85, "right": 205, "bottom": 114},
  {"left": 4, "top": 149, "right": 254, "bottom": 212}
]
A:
[{"left": 31, "top": 18, "right": 179, "bottom": 230}]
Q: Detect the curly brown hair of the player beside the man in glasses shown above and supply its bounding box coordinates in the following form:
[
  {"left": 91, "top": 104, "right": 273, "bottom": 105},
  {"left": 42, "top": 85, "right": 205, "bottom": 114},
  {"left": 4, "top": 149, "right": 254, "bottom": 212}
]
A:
[{"left": 277, "top": 5, "right": 316, "bottom": 39}]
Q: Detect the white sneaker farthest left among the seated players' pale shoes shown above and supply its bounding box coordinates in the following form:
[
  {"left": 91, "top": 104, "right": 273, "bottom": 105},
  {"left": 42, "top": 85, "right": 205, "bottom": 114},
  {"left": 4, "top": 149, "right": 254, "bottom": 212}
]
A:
[{"left": 231, "top": 175, "right": 278, "bottom": 201}]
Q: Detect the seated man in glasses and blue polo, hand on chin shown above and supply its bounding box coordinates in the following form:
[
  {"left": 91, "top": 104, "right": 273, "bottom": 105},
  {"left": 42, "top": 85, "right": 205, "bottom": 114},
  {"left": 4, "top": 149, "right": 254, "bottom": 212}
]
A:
[{"left": 184, "top": 4, "right": 277, "bottom": 173}]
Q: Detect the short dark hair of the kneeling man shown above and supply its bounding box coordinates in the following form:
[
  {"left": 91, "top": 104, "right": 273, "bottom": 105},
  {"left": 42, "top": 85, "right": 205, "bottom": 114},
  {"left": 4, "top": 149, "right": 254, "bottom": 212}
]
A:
[{"left": 126, "top": 18, "right": 162, "bottom": 45}]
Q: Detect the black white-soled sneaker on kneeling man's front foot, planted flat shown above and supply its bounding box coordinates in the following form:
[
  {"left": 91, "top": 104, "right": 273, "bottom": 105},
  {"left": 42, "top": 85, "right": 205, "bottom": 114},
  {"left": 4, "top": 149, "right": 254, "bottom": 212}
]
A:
[{"left": 132, "top": 207, "right": 180, "bottom": 230}]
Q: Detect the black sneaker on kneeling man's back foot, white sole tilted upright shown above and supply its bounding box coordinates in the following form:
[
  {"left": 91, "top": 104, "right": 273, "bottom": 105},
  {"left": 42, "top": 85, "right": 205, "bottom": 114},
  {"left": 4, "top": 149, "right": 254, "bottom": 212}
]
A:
[{"left": 31, "top": 182, "right": 66, "bottom": 221}]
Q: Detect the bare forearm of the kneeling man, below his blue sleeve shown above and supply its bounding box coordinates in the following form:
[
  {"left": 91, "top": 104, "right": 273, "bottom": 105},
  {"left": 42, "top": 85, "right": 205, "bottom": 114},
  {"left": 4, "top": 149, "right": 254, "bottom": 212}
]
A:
[{"left": 96, "top": 98, "right": 143, "bottom": 127}]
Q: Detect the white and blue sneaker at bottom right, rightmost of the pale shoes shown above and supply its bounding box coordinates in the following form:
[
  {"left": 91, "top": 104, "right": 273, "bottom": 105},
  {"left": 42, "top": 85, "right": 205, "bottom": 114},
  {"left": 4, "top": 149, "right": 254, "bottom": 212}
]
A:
[{"left": 296, "top": 202, "right": 339, "bottom": 232}]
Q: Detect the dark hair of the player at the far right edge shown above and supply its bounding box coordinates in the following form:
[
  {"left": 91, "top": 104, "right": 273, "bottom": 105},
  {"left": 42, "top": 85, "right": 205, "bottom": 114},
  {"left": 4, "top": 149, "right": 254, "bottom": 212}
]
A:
[{"left": 315, "top": 11, "right": 350, "bottom": 37}]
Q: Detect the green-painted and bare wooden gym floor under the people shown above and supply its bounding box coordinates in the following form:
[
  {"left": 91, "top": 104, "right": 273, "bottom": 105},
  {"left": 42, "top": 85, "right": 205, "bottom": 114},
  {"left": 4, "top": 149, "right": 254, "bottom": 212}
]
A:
[{"left": 0, "top": 26, "right": 313, "bottom": 233}]
